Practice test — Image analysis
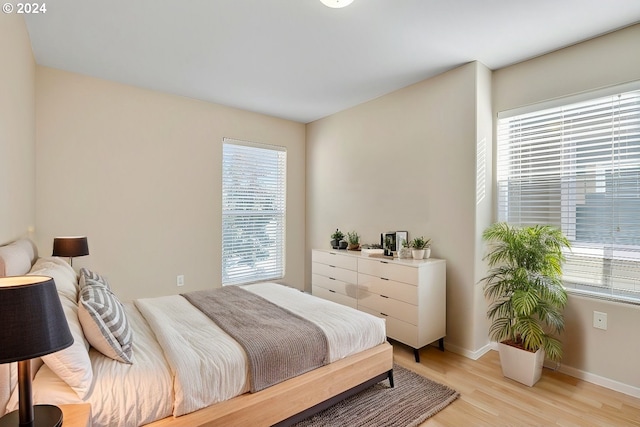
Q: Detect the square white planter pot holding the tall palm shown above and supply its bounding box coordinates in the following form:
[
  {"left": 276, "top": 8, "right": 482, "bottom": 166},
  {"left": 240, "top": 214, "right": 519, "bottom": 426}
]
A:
[{"left": 498, "top": 343, "right": 544, "bottom": 387}]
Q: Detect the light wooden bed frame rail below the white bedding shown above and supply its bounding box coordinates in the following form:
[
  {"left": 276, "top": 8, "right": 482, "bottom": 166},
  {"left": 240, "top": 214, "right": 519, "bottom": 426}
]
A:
[{"left": 148, "top": 343, "right": 393, "bottom": 427}]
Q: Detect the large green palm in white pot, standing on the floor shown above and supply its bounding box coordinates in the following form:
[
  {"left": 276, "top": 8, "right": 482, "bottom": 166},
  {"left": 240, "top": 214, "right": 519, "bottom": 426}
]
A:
[{"left": 481, "top": 222, "right": 570, "bottom": 387}]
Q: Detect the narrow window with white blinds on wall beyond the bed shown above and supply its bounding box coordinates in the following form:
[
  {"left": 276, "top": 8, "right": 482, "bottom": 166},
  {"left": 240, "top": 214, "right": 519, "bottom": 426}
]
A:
[{"left": 222, "top": 138, "right": 287, "bottom": 285}]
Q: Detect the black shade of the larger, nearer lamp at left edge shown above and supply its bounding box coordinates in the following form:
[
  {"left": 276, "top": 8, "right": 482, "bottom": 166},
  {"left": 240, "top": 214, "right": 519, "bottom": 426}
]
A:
[{"left": 0, "top": 276, "right": 73, "bottom": 363}]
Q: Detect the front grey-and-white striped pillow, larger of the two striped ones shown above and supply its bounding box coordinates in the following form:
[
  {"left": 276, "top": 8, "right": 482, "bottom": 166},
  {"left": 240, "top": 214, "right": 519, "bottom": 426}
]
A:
[{"left": 78, "top": 285, "right": 133, "bottom": 363}]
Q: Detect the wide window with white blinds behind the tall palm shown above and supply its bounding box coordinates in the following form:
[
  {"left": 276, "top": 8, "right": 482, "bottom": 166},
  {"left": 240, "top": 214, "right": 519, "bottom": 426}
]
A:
[{"left": 497, "top": 84, "right": 640, "bottom": 303}]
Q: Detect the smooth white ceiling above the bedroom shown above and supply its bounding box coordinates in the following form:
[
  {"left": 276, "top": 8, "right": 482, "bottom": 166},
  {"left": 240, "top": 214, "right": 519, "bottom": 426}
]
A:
[{"left": 25, "top": 0, "right": 640, "bottom": 123}]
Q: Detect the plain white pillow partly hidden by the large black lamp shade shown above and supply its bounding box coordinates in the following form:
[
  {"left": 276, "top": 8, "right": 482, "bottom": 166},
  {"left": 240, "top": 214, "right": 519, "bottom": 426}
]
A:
[{"left": 42, "top": 297, "right": 93, "bottom": 399}]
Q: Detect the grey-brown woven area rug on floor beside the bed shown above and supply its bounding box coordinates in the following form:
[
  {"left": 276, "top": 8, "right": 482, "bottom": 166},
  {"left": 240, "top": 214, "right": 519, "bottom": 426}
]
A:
[{"left": 294, "top": 365, "right": 459, "bottom": 427}]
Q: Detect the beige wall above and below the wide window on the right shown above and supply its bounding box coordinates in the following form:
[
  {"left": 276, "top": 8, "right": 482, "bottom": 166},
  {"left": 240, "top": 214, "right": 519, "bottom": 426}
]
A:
[{"left": 493, "top": 25, "right": 640, "bottom": 396}]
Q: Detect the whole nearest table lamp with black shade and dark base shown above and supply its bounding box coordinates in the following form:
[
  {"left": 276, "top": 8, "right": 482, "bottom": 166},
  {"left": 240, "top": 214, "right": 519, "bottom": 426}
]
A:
[{"left": 0, "top": 276, "right": 73, "bottom": 427}]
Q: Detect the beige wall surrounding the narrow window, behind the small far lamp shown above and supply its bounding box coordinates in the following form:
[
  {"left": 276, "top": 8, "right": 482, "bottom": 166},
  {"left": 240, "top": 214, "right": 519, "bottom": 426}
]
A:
[{"left": 36, "top": 67, "right": 305, "bottom": 300}]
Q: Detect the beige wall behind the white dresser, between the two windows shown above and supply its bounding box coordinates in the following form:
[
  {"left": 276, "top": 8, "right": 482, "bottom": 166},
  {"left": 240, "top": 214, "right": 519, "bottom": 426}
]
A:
[{"left": 306, "top": 63, "right": 491, "bottom": 360}]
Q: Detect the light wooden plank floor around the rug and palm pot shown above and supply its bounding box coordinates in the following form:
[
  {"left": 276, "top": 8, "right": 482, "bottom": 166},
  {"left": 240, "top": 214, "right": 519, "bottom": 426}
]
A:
[{"left": 392, "top": 342, "right": 640, "bottom": 427}]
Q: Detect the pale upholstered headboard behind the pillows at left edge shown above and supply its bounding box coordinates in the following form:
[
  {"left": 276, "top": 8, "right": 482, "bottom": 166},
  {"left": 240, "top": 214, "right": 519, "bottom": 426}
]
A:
[{"left": 0, "top": 239, "right": 38, "bottom": 416}]
